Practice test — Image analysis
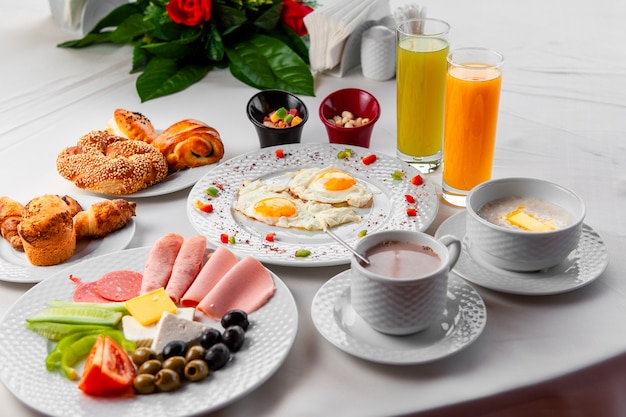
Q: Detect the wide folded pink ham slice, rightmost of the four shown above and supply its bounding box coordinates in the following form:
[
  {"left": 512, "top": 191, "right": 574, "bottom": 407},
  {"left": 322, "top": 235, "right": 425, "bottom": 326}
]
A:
[{"left": 197, "top": 256, "right": 276, "bottom": 320}]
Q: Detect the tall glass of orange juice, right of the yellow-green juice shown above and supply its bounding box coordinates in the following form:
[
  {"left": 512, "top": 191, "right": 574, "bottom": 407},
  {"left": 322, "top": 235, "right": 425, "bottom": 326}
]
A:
[{"left": 442, "top": 48, "right": 504, "bottom": 207}]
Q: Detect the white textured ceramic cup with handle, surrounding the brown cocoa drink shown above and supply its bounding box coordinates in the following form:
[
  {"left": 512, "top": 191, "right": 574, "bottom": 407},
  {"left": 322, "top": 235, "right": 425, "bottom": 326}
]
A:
[{"left": 350, "top": 230, "right": 461, "bottom": 335}]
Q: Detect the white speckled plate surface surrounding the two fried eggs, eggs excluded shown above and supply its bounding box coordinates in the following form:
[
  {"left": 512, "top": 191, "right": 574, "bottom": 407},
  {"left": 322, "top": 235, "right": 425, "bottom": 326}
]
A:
[{"left": 187, "top": 144, "right": 439, "bottom": 266}]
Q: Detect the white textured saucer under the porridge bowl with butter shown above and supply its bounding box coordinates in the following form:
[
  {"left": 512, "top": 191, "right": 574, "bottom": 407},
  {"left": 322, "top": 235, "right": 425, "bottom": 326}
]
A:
[{"left": 435, "top": 212, "right": 609, "bottom": 295}]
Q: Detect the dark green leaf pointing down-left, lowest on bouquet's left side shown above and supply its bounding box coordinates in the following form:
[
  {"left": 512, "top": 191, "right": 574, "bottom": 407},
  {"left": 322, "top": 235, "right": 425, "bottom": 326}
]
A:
[{"left": 136, "top": 57, "right": 211, "bottom": 102}]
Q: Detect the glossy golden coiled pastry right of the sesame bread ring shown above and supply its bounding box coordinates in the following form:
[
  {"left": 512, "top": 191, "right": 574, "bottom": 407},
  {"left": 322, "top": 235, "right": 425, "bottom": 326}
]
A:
[{"left": 152, "top": 119, "right": 224, "bottom": 172}]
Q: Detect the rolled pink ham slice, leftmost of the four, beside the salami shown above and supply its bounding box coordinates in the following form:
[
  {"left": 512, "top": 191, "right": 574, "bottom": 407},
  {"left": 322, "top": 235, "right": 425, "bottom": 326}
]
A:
[{"left": 140, "top": 233, "right": 185, "bottom": 294}]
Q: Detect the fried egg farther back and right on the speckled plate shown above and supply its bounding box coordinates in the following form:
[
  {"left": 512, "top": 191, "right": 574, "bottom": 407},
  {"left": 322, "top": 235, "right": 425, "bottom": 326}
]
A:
[{"left": 287, "top": 165, "right": 373, "bottom": 207}]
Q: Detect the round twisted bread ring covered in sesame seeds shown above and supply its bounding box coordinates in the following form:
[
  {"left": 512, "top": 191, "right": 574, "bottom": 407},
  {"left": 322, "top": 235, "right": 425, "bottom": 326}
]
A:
[{"left": 56, "top": 130, "right": 168, "bottom": 195}]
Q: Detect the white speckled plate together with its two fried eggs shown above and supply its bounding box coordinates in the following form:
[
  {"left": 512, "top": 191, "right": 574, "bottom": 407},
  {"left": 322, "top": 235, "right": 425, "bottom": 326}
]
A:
[{"left": 187, "top": 143, "right": 439, "bottom": 267}]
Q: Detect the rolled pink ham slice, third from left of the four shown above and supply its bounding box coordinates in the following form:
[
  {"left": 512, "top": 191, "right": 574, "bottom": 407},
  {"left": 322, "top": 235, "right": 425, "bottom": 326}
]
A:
[{"left": 180, "top": 246, "right": 238, "bottom": 307}]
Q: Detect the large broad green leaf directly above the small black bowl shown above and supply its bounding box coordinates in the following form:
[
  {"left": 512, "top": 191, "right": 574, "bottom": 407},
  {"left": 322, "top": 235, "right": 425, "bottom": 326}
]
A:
[{"left": 226, "top": 35, "right": 315, "bottom": 96}]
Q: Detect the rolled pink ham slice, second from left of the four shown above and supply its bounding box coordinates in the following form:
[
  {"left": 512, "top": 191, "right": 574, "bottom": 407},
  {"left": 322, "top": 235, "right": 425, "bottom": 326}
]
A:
[{"left": 165, "top": 235, "right": 207, "bottom": 303}]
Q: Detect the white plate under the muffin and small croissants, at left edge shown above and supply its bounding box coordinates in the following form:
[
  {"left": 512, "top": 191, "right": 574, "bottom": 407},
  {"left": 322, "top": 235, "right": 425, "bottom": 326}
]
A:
[{"left": 0, "top": 196, "right": 135, "bottom": 283}]
